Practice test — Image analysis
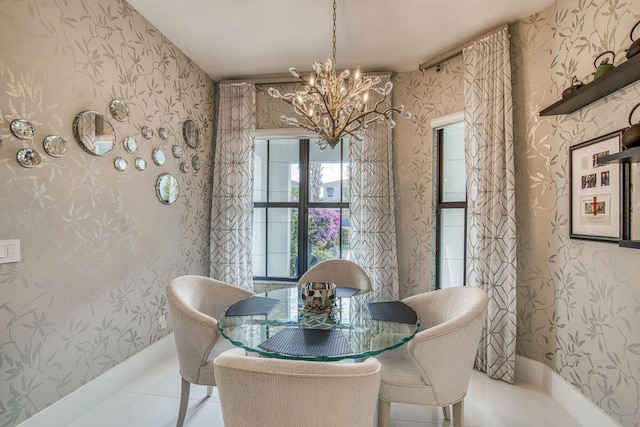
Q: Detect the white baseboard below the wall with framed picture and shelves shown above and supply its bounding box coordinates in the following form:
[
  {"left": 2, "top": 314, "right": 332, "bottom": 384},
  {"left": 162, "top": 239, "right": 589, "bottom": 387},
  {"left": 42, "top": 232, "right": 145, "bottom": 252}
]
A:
[{"left": 516, "top": 355, "right": 620, "bottom": 427}]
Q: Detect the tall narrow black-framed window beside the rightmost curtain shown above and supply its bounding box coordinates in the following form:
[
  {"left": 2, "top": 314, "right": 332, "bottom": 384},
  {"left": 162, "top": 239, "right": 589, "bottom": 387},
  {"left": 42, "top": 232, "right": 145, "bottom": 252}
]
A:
[{"left": 435, "top": 122, "right": 467, "bottom": 289}]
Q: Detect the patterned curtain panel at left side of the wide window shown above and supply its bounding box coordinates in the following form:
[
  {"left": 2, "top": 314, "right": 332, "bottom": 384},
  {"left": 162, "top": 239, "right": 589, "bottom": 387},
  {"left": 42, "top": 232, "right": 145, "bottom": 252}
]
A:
[{"left": 210, "top": 83, "right": 256, "bottom": 291}]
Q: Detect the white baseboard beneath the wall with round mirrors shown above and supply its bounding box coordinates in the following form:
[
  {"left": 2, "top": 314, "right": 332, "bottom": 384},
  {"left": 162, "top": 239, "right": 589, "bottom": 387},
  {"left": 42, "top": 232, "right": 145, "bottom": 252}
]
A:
[{"left": 18, "top": 334, "right": 176, "bottom": 427}]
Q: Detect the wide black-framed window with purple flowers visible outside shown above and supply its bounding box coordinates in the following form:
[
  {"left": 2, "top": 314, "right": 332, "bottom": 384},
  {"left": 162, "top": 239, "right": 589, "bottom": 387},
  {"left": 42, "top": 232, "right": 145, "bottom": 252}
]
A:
[{"left": 252, "top": 139, "right": 349, "bottom": 281}]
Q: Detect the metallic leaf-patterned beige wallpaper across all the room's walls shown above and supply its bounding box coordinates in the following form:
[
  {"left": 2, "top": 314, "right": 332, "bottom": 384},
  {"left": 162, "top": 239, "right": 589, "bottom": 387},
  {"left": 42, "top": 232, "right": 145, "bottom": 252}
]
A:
[{"left": 0, "top": 0, "right": 640, "bottom": 426}]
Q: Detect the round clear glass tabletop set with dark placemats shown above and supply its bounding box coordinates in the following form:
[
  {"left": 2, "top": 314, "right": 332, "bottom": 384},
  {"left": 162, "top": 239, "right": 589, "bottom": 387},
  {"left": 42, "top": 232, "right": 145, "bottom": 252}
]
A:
[{"left": 218, "top": 287, "right": 420, "bottom": 361}]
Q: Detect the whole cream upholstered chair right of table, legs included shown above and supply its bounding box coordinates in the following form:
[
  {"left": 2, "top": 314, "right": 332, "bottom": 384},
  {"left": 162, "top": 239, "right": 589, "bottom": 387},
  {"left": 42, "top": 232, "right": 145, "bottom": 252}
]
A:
[{"left": 377, "top": 286, "right": 489, "bottom": 427}]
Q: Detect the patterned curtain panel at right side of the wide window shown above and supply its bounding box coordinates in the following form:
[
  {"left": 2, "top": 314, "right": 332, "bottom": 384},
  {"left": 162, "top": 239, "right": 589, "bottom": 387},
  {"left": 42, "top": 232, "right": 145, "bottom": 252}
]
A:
[{"left": 349, "top": 75, "right": 399, "bottom": 298}]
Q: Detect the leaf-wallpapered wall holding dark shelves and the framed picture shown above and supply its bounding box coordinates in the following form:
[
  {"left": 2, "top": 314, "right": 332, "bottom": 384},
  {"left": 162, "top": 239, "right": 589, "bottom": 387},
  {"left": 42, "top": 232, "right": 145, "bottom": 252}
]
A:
[{"left": 513, "top": 0, "right": 640, "bottom": 426}]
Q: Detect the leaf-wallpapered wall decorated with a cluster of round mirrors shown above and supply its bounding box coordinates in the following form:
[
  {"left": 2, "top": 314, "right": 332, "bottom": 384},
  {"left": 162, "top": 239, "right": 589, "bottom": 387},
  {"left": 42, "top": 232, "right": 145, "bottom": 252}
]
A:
[{"left": 0, "top": 0, "right": 214, "bottom": 426}]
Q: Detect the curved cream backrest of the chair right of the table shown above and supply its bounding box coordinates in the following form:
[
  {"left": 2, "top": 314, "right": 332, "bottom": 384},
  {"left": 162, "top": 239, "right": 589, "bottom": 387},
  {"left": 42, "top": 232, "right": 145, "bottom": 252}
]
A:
[{"left": 403, "top": 286, "right": 489, "bottom": 406}]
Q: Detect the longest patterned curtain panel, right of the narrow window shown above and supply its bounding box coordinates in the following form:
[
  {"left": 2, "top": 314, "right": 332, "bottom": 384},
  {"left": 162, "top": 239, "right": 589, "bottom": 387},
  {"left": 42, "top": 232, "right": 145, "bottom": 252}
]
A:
[{"left": 463, "top": 28, "right": 516, "bottom": 382}]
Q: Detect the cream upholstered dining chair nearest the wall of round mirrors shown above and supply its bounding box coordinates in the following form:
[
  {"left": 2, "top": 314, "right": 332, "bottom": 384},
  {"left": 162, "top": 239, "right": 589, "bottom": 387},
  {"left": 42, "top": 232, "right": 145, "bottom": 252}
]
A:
[{"left": 166, "top": 276, "right": 253, "bottom": 427}]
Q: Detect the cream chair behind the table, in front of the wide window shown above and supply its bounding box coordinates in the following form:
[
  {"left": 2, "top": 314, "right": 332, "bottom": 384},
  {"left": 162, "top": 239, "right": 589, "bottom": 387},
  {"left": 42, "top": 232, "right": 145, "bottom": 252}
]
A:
[{"left": 298, "top": 259, "right": 371, "bottom": 291}]
